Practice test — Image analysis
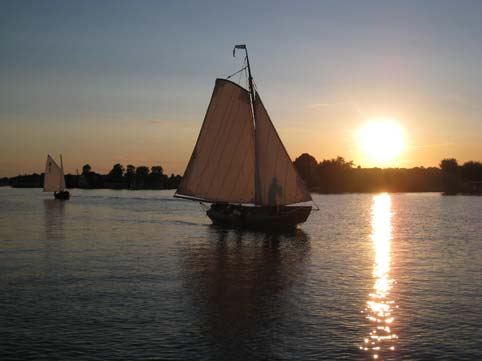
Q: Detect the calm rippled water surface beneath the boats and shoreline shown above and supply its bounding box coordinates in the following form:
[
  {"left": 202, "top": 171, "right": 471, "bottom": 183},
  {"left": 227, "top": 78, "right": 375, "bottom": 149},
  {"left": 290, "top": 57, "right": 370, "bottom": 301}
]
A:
[{"left": 0, "top": 188, "right": 482, "bottom": 360}]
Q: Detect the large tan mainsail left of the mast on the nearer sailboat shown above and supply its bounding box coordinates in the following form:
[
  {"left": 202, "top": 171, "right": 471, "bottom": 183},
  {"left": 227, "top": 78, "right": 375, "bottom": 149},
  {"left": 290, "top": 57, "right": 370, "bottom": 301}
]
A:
[{"left": 176, "top": 79, "right": 255, "bottom": 203}]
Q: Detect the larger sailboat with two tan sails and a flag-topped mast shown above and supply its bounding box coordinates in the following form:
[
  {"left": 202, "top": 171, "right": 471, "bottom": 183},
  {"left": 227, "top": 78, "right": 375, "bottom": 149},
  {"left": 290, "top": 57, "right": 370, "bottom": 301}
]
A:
[{"left": 174, "top": 45, "right": 312, "bottom": 228}]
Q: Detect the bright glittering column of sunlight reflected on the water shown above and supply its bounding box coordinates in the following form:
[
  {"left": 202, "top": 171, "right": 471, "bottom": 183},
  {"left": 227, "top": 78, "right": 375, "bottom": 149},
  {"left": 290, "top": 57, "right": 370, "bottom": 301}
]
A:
[{"left": 360, "top": 193, "right": 398, "bottom": 359}]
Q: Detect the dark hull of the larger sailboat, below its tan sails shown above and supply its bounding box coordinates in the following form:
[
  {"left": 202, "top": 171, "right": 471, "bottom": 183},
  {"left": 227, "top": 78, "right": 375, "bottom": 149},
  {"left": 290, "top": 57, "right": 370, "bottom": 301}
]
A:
[{"left": 206, "top": 204, "right": 311, "bottom": 229}]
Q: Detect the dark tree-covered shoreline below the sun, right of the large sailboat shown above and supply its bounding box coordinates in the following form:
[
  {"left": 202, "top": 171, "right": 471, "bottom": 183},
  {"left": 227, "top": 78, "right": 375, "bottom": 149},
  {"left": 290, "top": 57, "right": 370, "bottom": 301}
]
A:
[{"left": 294, "top": 153, "right": 482, "bottom": 194}]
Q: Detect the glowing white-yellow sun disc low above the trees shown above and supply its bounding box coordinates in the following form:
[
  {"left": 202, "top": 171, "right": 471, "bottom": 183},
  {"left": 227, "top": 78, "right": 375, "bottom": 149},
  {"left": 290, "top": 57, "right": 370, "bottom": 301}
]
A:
[{"left": 358, "top": 119, "right": 405, "bottom": 166}]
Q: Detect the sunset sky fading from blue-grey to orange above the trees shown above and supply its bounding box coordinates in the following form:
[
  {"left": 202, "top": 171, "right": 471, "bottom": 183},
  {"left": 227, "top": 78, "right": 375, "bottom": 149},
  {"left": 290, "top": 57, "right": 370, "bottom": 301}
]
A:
[{"left": 0, "top": 0, "right": 482, "bottom": 176}]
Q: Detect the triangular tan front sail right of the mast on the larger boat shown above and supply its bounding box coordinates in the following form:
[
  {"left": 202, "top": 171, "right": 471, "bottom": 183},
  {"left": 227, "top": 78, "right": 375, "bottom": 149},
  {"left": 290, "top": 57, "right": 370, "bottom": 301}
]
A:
[{"left": 254, "top": 94, "right": 311, "bottom": 206}]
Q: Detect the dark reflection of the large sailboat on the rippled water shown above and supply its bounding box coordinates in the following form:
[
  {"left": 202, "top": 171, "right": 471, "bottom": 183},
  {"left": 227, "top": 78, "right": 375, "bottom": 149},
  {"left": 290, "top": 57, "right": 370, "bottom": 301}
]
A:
[{"left": 181, "top": 226, "right": 310, "bottom": 360}]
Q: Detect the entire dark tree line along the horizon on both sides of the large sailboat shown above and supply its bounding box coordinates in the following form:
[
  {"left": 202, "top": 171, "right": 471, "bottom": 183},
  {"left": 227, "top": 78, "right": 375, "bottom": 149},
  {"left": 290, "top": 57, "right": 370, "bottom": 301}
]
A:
[{"left": 0, "top": 153, "right": 482, "bottom": 194}]
